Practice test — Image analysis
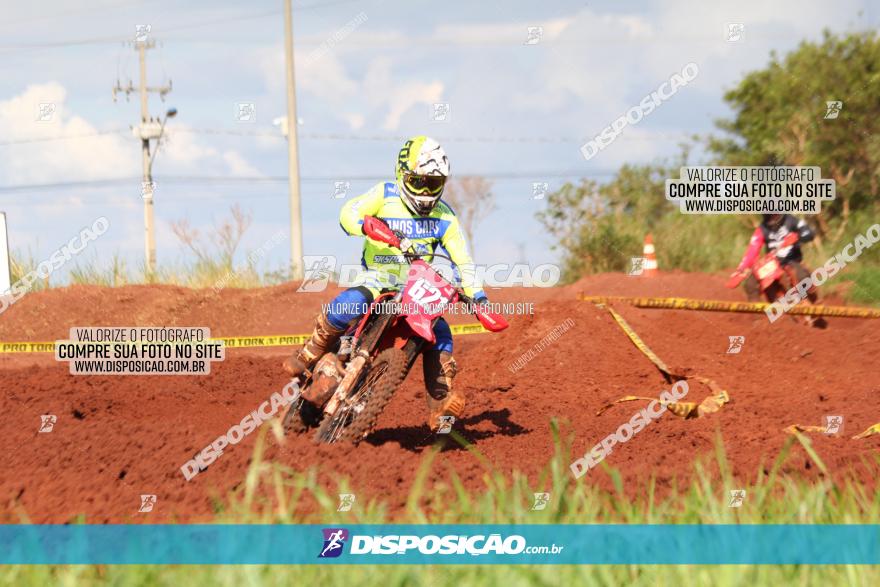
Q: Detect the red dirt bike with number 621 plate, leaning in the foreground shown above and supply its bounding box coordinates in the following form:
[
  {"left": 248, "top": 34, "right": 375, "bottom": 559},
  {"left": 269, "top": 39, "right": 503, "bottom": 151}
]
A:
[{"left": 283, "top": 216, "right": 508, "bottom": 444}]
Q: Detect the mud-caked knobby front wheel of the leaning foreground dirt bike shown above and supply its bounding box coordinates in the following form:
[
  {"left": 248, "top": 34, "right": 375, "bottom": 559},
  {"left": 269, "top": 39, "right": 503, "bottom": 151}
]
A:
[{"left": 315, "top": 348, "right": 409, "bottom": 444}]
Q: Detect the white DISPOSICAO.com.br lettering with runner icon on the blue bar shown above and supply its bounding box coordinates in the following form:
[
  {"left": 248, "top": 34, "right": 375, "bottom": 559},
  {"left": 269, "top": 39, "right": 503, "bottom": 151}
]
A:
[{"left": 318, "top": 528, "right": 565, "bottom": 558}]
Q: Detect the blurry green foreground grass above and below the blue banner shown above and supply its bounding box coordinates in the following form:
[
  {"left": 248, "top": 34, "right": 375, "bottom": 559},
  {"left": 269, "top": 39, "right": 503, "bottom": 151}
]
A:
[{"left": 0, "top": 430, "right": 880, "bottom": 587}]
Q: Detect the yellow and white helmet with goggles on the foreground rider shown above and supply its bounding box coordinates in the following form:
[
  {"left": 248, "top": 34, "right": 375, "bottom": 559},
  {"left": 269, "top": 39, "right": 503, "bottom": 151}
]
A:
[{"left": 397, "top": 135, "right": 449, "bottom": 216}]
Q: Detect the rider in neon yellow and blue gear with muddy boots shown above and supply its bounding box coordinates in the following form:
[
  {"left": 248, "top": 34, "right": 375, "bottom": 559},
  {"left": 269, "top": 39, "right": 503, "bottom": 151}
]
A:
[{"left": 284, "top": 136, "right": 488, "bottom": 430}]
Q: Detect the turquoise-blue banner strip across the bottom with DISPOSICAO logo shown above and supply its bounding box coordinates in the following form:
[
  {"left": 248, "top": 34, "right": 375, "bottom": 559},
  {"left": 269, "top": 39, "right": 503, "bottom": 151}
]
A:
[{"left": 0, "top": 524, "right": 880, "bottom": 565}]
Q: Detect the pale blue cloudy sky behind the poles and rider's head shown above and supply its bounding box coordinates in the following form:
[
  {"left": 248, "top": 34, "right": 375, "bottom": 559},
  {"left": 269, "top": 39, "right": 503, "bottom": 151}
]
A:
[{"left": 0, "top": 0, "right": 880, "bottom": 279}]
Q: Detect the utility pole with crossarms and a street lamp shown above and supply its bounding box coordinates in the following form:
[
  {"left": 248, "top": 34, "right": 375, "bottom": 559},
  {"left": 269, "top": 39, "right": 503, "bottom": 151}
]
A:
[{"left": 113, "top": 28, "right": 177, "bottom": 278}]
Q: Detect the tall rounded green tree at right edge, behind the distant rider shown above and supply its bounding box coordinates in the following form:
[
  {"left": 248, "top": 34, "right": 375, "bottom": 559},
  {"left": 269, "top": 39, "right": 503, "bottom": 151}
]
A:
[{"left": 709, "top": 31, "right": 880, "bottom": 238}]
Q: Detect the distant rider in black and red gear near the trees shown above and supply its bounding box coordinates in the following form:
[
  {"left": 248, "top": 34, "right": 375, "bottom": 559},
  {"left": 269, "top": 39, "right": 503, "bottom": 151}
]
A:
[{"left": 731, "top": 214, "right": 819, "bottom": 304}]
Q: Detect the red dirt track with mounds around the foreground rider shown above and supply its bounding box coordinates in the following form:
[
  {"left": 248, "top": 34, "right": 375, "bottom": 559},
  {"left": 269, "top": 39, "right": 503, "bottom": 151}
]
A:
[{"left": 0, "top": 273, "right": 880, "bottom": 523}]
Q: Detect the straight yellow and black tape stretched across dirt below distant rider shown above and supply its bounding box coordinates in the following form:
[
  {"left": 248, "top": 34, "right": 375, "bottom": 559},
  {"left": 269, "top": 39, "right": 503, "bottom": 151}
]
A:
[{"left": 578, "top": 293, "right": 880, "bottom": 318}]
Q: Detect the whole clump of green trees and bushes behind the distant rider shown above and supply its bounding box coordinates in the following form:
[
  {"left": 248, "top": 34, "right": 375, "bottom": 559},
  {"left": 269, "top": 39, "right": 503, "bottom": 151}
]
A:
[{"left": 538, "top": 32, "right": 880, "bottom": 281}]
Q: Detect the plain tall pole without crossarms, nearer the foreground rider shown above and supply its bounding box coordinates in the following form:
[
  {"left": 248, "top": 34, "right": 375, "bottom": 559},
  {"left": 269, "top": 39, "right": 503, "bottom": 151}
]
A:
[{"left": 284, "top": 0, "right": 303, "bottom": 280}]
